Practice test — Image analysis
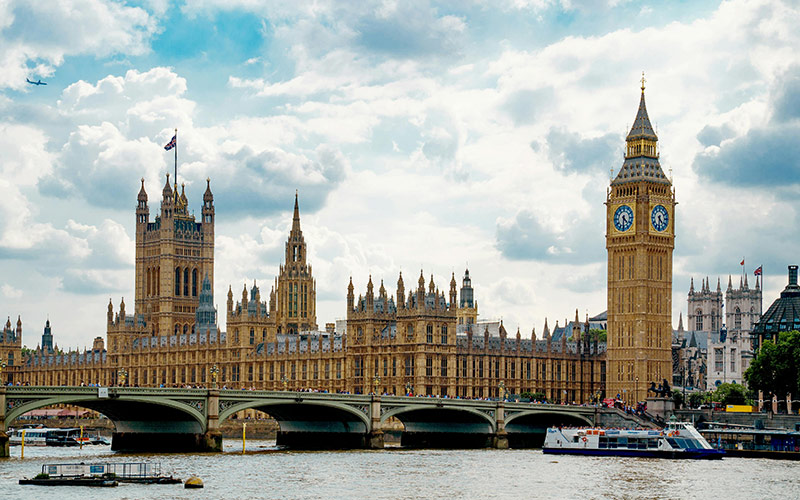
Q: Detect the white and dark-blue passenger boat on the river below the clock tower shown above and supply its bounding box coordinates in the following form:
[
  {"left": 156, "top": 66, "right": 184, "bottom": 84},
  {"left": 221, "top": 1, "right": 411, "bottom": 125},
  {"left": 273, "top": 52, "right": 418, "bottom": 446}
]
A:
[{"left": 542, "top": 422, "right": 725, "bottom": 459}]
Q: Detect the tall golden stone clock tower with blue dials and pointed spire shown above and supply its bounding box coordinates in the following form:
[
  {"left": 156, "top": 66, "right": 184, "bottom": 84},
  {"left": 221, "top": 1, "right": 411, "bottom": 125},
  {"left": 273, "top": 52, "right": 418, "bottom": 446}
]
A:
[{"left": 606, "top": 78, "right": 676, "bottom": 403}]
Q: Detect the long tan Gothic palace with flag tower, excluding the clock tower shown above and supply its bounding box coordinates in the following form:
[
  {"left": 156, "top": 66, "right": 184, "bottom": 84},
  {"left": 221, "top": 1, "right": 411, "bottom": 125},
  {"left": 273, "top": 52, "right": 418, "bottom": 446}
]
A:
[{"left": 15, "top": 174, "right": 606, "bottom": 402}]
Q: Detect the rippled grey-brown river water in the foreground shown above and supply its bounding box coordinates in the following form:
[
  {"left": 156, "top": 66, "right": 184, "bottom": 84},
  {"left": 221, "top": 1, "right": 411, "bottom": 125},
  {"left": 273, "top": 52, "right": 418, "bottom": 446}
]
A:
[{"left": 0, "top": 440, "right": 800, "bottom": 500}]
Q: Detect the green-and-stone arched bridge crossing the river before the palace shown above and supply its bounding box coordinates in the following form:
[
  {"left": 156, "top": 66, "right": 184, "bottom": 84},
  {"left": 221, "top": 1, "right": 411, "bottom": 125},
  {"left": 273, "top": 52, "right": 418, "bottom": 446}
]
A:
[{"left": 0, "top": 386, "right": 618, "bottom": 457}]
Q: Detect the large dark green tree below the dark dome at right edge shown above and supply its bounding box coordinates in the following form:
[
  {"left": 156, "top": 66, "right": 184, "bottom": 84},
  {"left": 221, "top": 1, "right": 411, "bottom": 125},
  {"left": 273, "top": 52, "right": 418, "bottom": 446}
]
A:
[{"left": 744, "top": 330, "right": 800, "bottom": 398}]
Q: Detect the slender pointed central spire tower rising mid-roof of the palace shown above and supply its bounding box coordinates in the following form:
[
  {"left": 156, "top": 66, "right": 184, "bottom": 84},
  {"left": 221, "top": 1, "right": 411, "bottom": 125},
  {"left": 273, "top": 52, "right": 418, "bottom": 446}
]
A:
[{"left": 275, "top": 193, "right": 317, "bottom": 334}]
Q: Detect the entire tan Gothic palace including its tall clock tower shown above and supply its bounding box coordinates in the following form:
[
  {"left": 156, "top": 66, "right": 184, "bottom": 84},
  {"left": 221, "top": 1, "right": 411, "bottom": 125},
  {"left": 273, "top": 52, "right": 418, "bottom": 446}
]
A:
[{"left": 0, "top": 86, "right": 760, "bottom": 402}]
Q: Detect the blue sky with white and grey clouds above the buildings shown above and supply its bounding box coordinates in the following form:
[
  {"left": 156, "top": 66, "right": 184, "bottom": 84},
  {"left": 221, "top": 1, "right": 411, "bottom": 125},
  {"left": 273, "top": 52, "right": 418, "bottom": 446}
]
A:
[{"left": 0, "top": 0, "right": 800, "bottom": 347}]
